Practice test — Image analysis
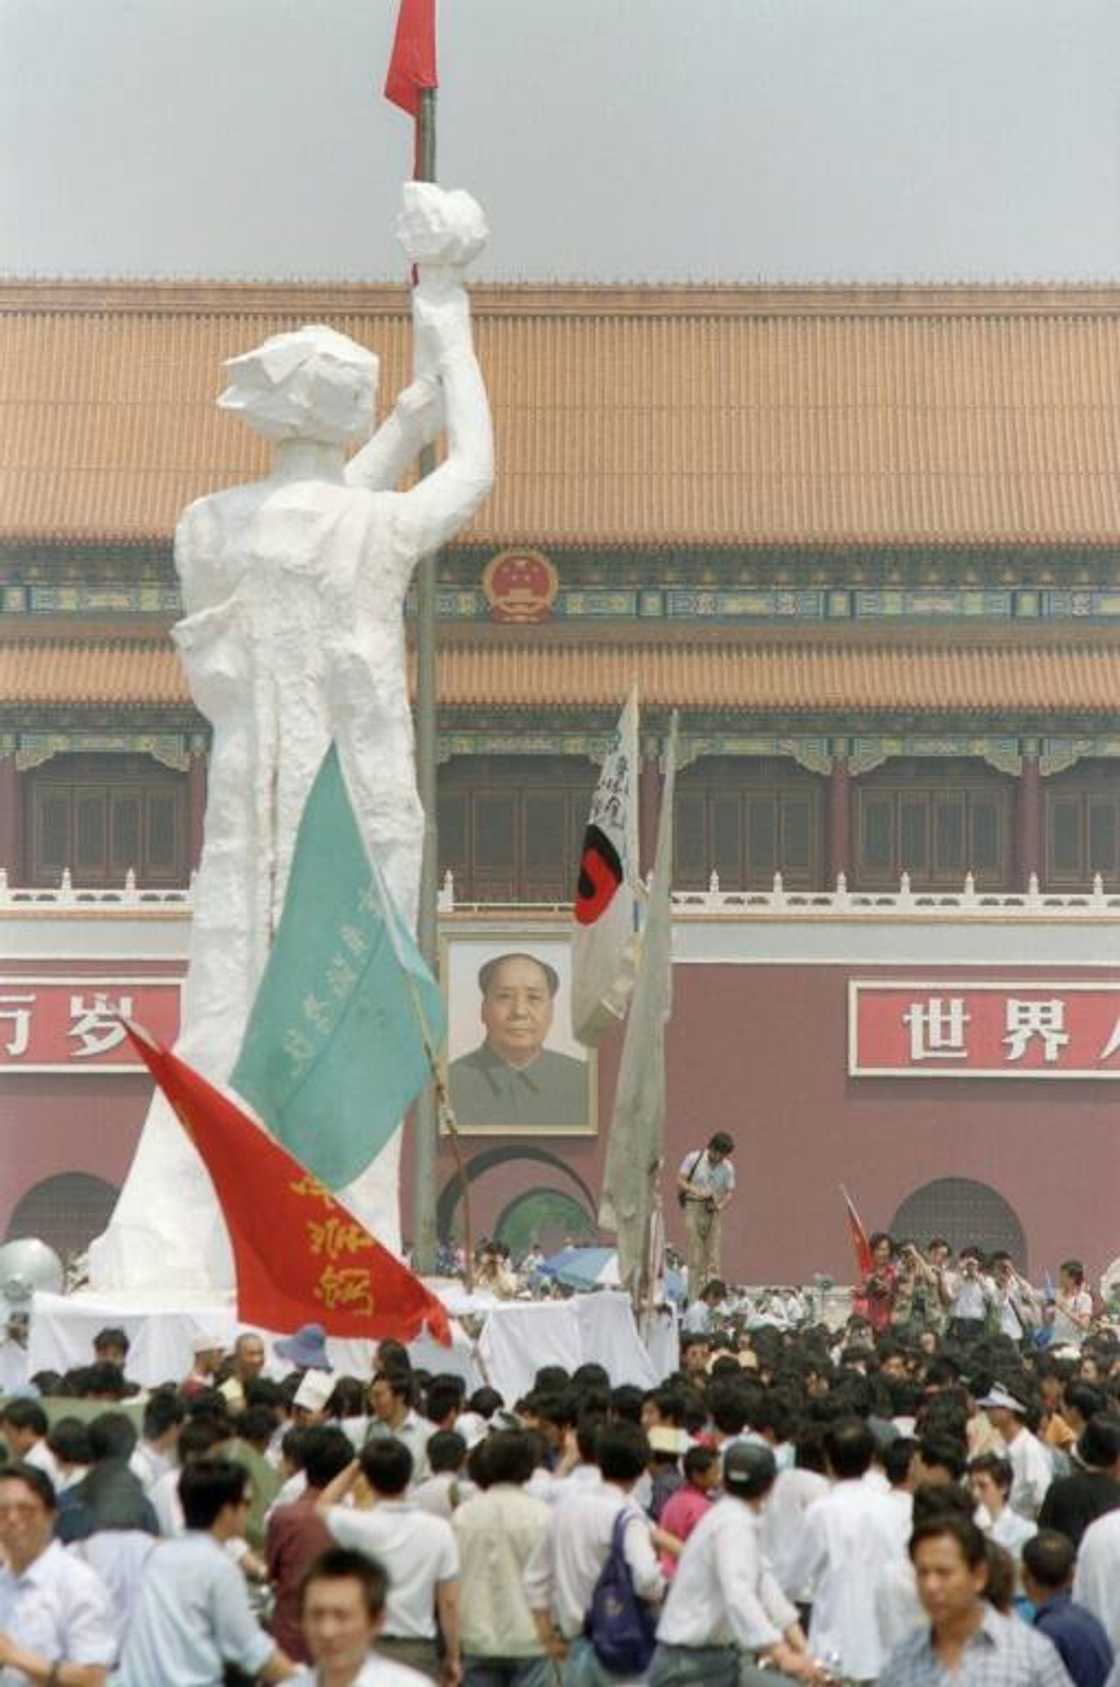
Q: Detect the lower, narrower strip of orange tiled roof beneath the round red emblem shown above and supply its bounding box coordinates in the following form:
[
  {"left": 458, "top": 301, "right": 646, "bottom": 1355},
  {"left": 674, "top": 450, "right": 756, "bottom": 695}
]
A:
[{"left": 0, "top": 638, "right": 1120, "bottom": 715}]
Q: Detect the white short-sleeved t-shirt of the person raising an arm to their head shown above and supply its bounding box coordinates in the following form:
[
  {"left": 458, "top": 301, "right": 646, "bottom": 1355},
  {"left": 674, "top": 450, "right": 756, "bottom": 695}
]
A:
[{"left": 324, "top": 1500, "right": 459, "bottom": 1640}]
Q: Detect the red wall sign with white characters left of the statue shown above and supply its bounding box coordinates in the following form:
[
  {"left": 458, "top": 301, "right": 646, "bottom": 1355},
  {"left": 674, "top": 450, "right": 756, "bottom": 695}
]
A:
[{"left": 0, "top": 975, "right": 180, "bottom": 1073}]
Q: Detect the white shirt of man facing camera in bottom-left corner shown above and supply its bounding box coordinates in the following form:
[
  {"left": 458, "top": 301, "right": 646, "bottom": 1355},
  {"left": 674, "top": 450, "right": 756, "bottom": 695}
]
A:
[{"left": 0, "top": 1540, "right": 116, "bottom": 1687}]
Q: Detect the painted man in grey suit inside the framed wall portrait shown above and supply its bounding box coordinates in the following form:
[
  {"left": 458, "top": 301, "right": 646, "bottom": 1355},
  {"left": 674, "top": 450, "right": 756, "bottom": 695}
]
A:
[{"left": 449, "top": 953, "right": 589, "bottom": 1130}]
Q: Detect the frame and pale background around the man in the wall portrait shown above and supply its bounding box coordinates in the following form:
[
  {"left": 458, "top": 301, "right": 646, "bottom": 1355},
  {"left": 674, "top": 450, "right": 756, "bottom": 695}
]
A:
[{"left": 440, "top": 924, "right": 599, "bottom": 1139}]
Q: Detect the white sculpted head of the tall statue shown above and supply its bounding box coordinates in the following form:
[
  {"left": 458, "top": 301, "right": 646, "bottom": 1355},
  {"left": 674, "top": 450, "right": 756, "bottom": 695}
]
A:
[{"left": 218, "top": 322, "right": 378, "bottom": 445}]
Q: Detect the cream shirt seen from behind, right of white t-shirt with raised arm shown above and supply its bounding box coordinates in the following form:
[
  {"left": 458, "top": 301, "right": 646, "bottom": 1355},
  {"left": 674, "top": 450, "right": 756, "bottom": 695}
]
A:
[{"left": 452, "top": 1471, "right": 549, "bottom": 1658}]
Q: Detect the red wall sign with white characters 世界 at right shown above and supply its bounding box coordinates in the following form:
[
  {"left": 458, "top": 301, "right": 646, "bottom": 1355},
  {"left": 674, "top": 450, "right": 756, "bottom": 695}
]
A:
[{"left": 848, "top": 978, "right": 1120, "bottom": 1080}]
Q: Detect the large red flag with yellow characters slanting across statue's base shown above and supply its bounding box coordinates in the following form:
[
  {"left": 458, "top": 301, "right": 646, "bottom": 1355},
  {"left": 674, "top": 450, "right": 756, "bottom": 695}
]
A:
[{"left": 123, "top": 1021, "right": 450, "bottom": 1346}]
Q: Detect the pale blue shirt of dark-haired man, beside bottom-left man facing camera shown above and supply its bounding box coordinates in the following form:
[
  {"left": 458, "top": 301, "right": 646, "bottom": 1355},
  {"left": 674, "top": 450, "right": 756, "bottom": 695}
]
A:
[{"left": 113, "top": 1528, "right": 275, "bottom": 1687}]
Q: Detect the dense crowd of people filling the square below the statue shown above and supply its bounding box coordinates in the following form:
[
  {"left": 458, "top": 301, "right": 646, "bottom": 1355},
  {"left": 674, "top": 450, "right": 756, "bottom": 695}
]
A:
[{"left": 0, "top": 1237, "right": 1120, "bottom": 1687}]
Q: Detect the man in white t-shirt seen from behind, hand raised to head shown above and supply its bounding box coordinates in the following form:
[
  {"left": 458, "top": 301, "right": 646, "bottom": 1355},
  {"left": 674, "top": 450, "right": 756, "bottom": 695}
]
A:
[{"left": 315, "top": 1436, "right": 460, "bottom": 1687}]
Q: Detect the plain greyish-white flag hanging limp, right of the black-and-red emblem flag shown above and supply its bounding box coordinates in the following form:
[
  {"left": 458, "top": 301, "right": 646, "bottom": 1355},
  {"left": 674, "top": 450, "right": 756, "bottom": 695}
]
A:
[{"left": 599, "top": 715, "right": 676, "bottom": 1294}]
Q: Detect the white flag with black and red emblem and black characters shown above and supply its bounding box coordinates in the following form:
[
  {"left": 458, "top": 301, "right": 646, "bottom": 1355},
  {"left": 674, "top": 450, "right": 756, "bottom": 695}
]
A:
[{"left": 572, "top": 687, "right": 643, "bottom": 1046}]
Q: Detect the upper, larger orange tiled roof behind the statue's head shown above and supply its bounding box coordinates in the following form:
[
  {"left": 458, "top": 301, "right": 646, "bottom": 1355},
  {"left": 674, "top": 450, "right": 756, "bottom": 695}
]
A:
[{"left": 0, "top": 283, "right": 1120, "bottom": 548}]
